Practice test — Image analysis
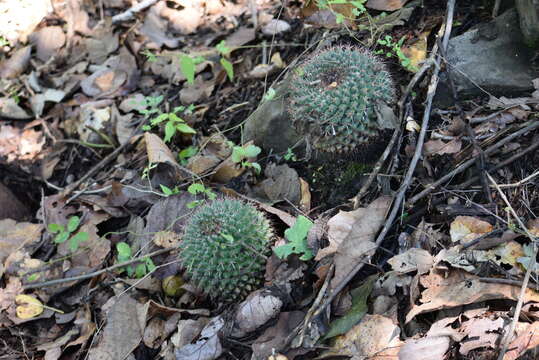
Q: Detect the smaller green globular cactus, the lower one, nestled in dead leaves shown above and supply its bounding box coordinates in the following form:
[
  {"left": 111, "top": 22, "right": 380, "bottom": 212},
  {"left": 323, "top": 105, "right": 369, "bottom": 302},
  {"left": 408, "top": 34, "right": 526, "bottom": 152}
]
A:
[{"left": 180, "top": 199, "right": 272, "bottom": 301}]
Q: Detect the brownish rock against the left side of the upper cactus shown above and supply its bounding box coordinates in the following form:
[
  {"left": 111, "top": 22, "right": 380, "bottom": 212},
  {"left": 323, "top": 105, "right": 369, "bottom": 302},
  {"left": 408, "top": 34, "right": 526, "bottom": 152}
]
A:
[{"left": 242, "top": 79, "right": 304, "bottom": 154}]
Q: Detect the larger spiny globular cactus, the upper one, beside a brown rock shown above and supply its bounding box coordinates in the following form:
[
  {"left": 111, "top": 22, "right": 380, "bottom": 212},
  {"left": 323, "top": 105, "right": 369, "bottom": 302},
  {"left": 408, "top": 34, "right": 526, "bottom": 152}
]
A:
[{"left": 288, "top": 46, "right": 395, "bottom": 153}]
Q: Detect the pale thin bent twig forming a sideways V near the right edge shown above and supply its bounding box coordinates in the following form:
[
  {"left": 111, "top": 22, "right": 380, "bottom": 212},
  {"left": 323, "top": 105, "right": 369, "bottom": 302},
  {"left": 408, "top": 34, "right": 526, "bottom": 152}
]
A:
[{"left": 487, "top": 173, "right": 539, "bottom": 360}]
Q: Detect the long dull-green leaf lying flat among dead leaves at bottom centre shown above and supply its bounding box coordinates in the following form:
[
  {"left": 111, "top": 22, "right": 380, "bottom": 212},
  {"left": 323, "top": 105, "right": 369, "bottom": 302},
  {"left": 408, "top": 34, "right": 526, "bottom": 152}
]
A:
[{"left": 322, "top": 275, "right": 377, "bottom": 340}]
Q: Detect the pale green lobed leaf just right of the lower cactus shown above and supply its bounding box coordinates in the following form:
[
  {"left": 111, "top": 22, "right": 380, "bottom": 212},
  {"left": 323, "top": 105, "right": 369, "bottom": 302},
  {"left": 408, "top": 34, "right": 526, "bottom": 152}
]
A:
[{"left": 273, "top": 215, "right": 314, "bottom": 261}]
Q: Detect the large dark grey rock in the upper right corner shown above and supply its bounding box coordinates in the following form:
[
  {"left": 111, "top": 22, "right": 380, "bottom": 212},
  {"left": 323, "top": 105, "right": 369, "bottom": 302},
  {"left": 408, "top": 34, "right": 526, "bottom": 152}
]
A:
[{"left": 435, "top": 9, "right": 537, "bottom": 105}]
